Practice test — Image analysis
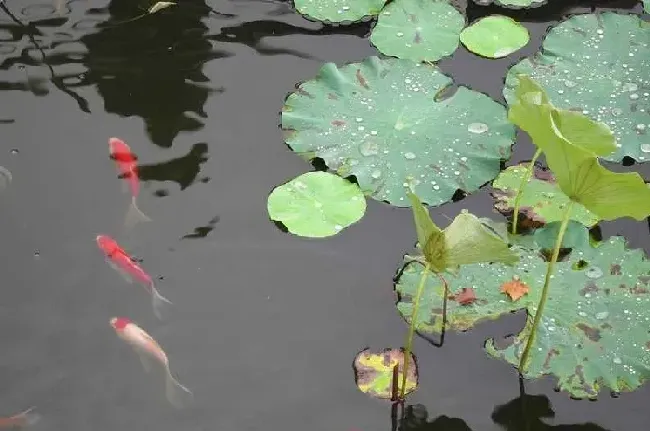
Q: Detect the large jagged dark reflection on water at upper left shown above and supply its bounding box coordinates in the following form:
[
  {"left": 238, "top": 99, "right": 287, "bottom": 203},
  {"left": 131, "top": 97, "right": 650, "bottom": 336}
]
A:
[{"left": 80, "top": 0, "right": 231, "bottom": 148}]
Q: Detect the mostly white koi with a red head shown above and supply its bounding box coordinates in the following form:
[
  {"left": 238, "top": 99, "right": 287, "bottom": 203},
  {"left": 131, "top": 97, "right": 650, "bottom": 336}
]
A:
[{"left": 110, "top": 317, "right": 194, "bottom": 408}]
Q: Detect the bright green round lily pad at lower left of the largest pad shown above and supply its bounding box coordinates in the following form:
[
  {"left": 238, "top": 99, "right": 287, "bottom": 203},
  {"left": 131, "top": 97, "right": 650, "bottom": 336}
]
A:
[{"left": 267, "top": 172, "right": 366, "bottom": 238}]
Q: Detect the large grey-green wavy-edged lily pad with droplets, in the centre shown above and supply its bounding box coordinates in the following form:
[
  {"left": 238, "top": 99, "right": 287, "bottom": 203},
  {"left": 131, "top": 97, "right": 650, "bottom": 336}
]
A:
[{"left": 282, "top": 57, "right": 514, "bottom": 206}]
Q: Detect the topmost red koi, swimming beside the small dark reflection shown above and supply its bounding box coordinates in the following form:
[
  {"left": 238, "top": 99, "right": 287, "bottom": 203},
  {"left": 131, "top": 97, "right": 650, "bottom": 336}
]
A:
[{"left": 108, "top": 138, "right": 151, "bottom": 227}]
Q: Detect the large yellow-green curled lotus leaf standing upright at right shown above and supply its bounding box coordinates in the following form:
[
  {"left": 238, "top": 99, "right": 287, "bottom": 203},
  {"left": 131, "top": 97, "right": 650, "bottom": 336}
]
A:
[{"left": 508, "top": 75, "right": 650, "bottom": 220}]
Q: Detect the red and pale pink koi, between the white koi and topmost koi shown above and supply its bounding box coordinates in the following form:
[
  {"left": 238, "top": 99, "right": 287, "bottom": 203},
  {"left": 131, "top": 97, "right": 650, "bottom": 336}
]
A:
[{"left": 96, "top": 235, "right": 172, "bottom": 319}]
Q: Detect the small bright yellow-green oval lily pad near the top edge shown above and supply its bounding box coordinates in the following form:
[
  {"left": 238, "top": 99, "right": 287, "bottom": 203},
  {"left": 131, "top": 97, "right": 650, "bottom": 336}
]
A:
[{"left": 460, "top": 15, "right": 530, "bottom": 58}]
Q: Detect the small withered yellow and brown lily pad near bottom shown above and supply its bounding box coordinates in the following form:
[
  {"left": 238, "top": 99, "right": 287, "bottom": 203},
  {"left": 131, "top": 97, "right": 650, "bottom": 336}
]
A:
[{"left": 354, "top": 349, "right": 418, "bottom": 399}]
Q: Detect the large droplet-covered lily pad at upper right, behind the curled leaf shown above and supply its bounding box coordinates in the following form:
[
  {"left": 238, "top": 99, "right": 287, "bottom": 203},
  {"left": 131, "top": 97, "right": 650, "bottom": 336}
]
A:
[{"left": 504, "top": 12, "right": 650, "bottom": 162}]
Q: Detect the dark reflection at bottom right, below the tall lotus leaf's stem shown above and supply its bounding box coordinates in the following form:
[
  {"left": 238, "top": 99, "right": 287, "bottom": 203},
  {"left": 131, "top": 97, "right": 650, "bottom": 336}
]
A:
[{"left": 492, "top": 378, "right": 608, "bottom": 431}]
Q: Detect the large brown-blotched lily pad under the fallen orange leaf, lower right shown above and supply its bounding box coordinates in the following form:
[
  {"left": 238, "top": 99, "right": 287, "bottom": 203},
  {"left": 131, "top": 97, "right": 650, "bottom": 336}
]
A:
[{"left": 396, "top": 237, "right": 650, "bottom": 398}]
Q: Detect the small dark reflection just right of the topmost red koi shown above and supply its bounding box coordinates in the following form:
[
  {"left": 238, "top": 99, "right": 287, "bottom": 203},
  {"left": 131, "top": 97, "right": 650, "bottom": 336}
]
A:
[{"left": 138, "top": 142, "right": 208, "bottom": 190}]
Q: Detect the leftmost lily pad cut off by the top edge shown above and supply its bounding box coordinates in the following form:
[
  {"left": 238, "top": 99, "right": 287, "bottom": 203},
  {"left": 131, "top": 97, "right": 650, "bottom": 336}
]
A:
[{"left": 295, "top": 0, "right": 386, "bottom": 22}]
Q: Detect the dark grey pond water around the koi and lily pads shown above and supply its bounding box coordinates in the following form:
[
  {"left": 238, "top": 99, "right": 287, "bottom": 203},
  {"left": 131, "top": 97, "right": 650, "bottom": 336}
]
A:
[{"left": 0, "top": 0, "right": 650, "bottom": 431}]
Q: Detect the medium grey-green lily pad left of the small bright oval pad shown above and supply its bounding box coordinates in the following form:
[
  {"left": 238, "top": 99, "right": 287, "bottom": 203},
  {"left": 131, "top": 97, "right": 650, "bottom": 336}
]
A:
[{"left": 370, "top": 0, "right": 465, "bottom": 61}]
